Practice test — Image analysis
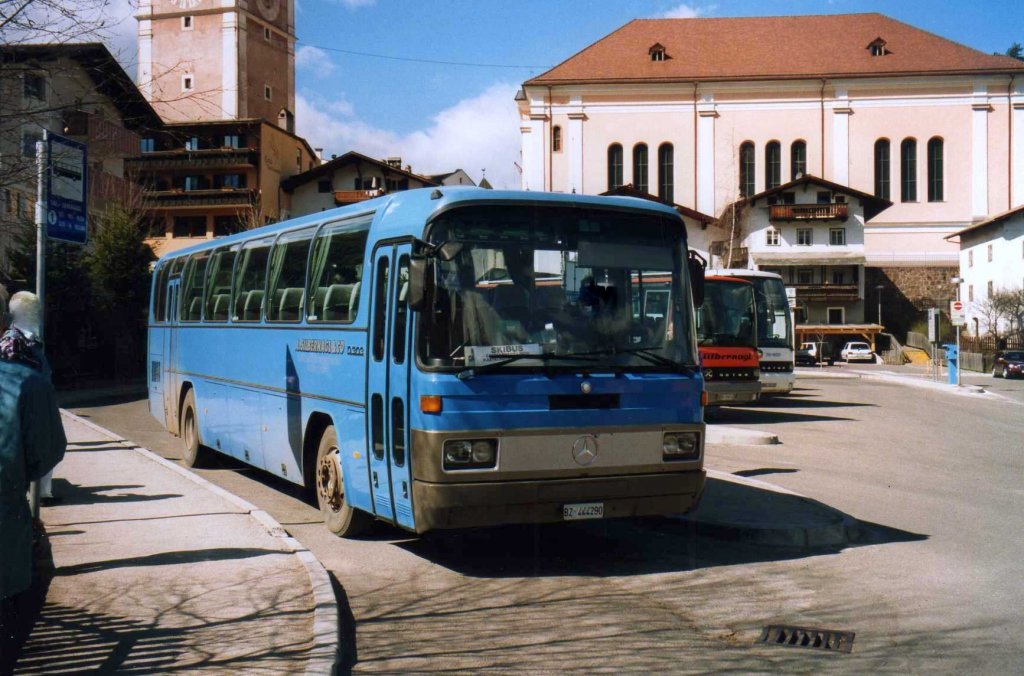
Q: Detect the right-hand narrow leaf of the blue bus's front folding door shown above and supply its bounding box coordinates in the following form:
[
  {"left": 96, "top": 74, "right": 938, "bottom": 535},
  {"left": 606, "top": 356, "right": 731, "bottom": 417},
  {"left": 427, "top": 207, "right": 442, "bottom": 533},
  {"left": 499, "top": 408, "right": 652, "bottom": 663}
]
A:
[{"left": 385, "top": 244, "right": 415, "bottom": 529}]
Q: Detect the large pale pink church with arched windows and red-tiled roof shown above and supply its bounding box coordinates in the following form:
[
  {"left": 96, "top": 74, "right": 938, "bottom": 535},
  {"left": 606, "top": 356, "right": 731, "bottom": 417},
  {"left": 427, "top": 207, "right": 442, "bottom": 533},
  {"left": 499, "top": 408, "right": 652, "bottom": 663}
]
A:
[{"left": 517, "top": 14, "right": 1024, "bottom": 338}]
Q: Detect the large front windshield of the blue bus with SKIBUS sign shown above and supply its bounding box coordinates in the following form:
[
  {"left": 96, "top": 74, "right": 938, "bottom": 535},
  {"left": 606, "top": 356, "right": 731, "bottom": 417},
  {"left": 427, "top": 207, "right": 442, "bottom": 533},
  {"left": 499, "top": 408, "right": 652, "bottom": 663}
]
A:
[{"left": 419, "top": 206, "right": 696, "bottom": 371}]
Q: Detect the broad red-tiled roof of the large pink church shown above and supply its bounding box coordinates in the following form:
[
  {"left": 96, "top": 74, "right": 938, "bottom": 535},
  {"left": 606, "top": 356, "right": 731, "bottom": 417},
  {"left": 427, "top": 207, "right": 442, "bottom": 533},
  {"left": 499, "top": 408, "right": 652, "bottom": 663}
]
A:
[{"left": 526, "top": 13, "right": 1024, "bottom": 85}]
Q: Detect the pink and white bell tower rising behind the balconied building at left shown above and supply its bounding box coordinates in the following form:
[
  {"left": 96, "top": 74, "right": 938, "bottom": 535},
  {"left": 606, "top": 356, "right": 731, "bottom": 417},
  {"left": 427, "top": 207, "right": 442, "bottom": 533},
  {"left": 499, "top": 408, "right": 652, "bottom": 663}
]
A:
[{"left": 136, "top": 0, "right": 295, "bottom": 131}]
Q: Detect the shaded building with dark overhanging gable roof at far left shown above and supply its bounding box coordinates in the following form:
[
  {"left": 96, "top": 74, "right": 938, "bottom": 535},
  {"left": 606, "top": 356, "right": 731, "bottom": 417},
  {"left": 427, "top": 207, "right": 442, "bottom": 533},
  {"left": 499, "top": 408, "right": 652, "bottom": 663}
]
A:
[{"left": 0, "top": 43, "right": 162, "bottom": 277}]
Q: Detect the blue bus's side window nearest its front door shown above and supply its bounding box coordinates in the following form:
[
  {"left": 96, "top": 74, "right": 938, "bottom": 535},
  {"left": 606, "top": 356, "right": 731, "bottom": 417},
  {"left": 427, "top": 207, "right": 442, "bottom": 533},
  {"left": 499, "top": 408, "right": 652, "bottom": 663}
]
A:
[{"left": 306, "top": 218, "right": 370, "bottom": 324}]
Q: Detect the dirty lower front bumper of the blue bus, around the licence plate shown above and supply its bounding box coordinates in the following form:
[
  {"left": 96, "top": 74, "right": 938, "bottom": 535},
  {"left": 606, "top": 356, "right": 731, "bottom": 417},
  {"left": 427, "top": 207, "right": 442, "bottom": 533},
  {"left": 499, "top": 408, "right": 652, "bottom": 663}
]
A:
[{"left": 413, "top": 469, "right": 705, "bottom": 533}]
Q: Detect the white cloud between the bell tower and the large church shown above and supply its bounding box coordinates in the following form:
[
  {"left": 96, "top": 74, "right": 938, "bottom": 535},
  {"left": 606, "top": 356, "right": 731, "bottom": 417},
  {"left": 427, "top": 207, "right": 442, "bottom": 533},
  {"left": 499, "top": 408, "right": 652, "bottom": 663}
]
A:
[{"left": 295, "top": 82, "right": 519, "bottom": 188}]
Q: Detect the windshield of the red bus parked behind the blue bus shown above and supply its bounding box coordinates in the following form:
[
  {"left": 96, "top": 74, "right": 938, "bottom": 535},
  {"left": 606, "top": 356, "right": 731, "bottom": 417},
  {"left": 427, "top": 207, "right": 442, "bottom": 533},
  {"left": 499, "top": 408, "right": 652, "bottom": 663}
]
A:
[{"left": 696, "top": 278, "right": 757, "bottom": 347}]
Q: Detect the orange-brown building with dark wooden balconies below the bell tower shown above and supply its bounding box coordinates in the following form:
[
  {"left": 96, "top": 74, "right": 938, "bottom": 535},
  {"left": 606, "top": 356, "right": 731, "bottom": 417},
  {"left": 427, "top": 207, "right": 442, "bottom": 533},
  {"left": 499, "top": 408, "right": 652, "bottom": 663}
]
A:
[{"left": 127, "top": 120, "right": 316, "bottom": 256}]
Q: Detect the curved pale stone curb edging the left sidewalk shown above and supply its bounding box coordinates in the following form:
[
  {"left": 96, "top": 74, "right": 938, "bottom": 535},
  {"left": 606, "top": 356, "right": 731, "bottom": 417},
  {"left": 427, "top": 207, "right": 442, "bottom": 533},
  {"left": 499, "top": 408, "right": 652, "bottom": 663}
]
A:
[{"left": 60, "top": 409, "right": 342, "bottom": 676}]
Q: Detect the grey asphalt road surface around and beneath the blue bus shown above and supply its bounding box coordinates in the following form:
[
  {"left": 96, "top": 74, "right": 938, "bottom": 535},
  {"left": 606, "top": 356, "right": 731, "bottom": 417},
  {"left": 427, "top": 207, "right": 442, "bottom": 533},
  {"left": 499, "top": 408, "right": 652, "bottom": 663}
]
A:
[{"left": 66, "top": 376, "right": 1024, "bottom": 673}]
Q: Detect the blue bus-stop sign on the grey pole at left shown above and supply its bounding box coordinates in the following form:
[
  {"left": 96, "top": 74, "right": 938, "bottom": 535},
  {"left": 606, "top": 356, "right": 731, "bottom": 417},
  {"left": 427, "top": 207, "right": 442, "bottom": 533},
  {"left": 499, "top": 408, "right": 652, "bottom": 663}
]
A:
[{"left": 46, "top": 132, "right": 89, "bottom": 244}]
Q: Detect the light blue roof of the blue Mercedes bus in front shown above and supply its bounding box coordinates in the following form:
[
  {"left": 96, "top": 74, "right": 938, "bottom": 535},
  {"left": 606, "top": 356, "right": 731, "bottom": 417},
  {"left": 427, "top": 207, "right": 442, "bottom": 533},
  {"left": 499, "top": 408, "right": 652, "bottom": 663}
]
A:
[{"left": 162, "top": 186, "right": 685, "bottom": 259}]
